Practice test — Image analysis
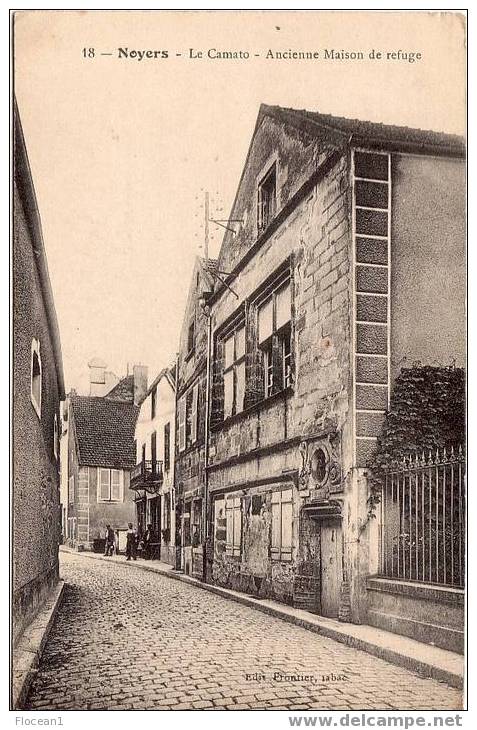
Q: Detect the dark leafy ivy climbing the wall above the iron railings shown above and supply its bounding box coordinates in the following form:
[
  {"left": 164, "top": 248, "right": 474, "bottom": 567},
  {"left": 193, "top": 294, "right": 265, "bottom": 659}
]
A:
[{"left": 362, "top": 364, "right": 465, "bottom": 529}]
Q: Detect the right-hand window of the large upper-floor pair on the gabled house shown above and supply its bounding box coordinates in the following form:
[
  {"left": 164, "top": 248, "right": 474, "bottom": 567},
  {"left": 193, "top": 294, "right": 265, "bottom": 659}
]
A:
[{"left": 258, "top": 281, "right": 292, "bottom": 397}]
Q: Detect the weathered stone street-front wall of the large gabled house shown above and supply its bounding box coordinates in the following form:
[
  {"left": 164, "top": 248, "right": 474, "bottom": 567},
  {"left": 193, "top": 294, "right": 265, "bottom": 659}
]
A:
[{"left": 209, "top": 120, "right": 354, "bottom": 611}]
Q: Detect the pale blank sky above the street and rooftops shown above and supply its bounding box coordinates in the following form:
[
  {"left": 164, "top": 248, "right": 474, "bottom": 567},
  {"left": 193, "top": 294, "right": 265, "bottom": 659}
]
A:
[{"left": 14, "top": 11, "right": 466, "bottom": 393}]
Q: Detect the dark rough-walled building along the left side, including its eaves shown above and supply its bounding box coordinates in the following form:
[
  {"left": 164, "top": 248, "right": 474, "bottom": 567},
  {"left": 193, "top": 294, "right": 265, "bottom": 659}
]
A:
[{"left": 12, "top": 104, "right": 65, "bottom": 641}]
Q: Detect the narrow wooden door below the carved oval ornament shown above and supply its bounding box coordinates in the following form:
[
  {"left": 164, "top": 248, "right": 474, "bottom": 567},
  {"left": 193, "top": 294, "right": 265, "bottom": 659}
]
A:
[{"left": 321, "top": 520, "right": 343, "bottom": 618}]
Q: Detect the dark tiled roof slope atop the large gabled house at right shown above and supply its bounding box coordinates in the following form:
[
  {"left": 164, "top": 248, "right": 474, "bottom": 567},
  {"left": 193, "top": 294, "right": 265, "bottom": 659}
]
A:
[{"left": 258, "top": 104, "right": 465, "bottom": 157}]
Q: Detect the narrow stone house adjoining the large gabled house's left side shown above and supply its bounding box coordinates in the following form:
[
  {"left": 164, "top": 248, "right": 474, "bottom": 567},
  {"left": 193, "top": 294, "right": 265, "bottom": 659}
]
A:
[{"left": 175, "top": 257, "right": 216, "bottom": 576}]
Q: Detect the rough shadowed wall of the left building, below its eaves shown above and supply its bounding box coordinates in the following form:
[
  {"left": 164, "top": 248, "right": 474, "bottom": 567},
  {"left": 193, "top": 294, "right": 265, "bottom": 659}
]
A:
[{"left": 12, "top": 179, "right": 61, "bottom": 639}]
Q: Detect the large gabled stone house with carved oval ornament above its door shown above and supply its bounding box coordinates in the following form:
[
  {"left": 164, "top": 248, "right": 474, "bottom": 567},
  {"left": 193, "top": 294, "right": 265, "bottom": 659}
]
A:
[{"left": 203, "top": 105, "right": 465, "bottom": 629}]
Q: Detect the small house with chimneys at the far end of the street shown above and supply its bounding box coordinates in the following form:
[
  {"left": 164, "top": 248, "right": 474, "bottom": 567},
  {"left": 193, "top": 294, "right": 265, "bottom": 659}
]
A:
[{"left": 66, "top": 361, "right": 147, "bottom": 550}]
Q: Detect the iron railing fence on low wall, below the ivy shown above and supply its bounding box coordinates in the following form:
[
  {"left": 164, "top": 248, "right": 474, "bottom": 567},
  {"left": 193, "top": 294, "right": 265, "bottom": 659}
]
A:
[{"left": 381, "top": 446, "right": 466, "bottom": 587}]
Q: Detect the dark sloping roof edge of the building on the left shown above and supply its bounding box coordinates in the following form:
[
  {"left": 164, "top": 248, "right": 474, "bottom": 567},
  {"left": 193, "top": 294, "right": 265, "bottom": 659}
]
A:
[{"left": 13, "top": 99, "right": 65, "bottom": 400}]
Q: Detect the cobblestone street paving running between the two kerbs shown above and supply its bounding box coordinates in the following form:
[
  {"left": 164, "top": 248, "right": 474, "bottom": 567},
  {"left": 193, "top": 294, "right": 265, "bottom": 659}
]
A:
[{"left": 27, "top": 553, "right": 462, "bottom": 710}]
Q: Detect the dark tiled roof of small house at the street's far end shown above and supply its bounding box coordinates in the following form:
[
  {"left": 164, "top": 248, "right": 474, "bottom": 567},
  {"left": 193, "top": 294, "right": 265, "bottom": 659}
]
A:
[{"left": 71, "top": 395, "right": 139, "bottom": 469}]
